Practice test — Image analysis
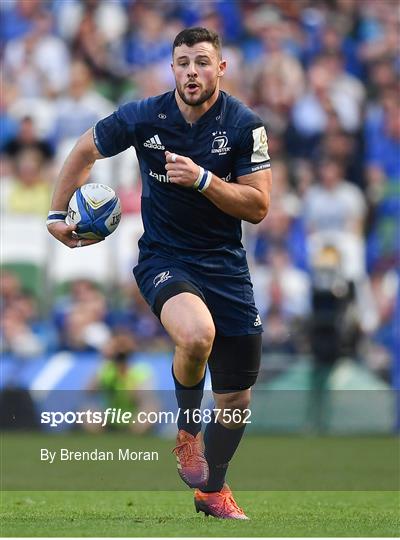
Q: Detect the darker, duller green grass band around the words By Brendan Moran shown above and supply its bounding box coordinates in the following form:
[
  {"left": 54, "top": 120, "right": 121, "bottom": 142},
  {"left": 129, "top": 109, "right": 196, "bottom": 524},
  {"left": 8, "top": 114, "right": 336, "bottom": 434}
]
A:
[{"left": 0, "top": 432, "right": 400, "bottom": 491}]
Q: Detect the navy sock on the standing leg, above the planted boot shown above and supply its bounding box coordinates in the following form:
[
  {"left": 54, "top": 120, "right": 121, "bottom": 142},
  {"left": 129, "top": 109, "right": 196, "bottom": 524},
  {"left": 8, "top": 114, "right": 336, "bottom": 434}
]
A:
[{"left": 202, "top": 413, "right": 246, "bottom": 492}]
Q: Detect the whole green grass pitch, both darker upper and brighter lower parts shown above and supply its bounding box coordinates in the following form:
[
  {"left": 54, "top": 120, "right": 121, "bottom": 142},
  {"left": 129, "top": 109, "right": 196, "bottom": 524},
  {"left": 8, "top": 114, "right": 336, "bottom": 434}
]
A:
[{"left": 0, "top": 433, "right": 400, "bottom": 537}]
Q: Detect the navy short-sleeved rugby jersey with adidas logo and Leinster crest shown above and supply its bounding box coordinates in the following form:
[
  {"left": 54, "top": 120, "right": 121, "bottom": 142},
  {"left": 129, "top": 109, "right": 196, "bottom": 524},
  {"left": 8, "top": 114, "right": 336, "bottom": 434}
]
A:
[{"left": 94, "top": 91, "right": 270, "bottom": 272}]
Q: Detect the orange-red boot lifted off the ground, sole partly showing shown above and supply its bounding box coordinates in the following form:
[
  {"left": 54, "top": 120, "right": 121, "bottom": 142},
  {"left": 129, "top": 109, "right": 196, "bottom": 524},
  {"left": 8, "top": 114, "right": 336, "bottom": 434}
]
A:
[{"left": 173, "top": 429, "right": 209, "bottom": 488}]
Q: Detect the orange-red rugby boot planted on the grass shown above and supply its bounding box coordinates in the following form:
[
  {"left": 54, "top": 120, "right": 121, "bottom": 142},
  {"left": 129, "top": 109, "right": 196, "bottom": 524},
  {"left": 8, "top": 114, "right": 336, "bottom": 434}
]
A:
[{"left": 194, "top": 484, "right": 249, "bottom": 519}]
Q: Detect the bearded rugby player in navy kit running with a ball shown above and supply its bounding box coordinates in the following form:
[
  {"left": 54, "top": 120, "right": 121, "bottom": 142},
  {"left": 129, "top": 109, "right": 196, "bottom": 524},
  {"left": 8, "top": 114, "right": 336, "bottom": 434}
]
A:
[{"left": 48, "top": 28, "right": 271, "bottom": 519}]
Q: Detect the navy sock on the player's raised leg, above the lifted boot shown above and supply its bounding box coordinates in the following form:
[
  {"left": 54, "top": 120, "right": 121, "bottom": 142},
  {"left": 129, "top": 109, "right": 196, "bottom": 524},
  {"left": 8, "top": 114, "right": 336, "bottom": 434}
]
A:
[{"left": 172, "top": 366, "right": 206, "bottom": 436}]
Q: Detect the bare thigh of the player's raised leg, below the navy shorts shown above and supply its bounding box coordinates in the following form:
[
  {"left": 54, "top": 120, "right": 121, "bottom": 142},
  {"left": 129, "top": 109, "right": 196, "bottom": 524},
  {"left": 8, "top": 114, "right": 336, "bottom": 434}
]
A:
[{"left": 160, "top": 292, "right": 215, "bottom": 347}]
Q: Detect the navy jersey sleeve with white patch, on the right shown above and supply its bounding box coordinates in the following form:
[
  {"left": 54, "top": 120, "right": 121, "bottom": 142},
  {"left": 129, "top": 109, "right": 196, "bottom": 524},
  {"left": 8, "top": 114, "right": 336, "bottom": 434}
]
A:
[{"left": 235, "top": 124, "right": 271, "bottom": 178}]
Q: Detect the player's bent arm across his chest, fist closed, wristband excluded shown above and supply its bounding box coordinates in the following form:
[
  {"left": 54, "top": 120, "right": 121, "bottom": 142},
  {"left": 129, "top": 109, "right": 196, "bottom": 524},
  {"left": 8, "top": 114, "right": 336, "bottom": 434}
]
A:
[{"left": 165, "top": 152, "right": 272, "bottom": 223}]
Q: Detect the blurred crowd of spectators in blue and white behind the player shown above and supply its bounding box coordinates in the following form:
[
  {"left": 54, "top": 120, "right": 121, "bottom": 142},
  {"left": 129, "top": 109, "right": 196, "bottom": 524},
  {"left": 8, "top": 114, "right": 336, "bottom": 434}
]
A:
[{"left": 0, "top": 0, "right": 400, "bottom": 381}]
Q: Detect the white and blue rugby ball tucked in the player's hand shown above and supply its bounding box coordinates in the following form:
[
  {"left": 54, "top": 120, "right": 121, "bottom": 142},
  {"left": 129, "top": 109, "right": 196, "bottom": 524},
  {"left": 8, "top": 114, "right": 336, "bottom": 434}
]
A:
[{"left": 66, "top": 184, "right": 121, "bottom": 240}]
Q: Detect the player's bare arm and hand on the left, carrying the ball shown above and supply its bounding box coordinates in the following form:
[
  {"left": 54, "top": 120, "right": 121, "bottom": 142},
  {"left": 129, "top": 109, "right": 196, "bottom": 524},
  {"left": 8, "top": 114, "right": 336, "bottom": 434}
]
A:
[{"left": 47, "top": 129, "right": 104, "bottom": 248}]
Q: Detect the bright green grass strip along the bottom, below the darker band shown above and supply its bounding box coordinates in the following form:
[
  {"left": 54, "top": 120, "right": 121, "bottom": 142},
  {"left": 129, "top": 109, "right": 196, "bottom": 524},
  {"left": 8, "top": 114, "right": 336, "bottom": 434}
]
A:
[{"left": 1, "top": 490, "right": 400, "bottom": 537}]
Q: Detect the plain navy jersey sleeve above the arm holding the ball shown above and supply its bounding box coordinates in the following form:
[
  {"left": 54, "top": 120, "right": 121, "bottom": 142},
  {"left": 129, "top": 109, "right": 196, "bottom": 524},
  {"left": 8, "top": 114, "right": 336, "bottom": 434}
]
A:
[{"left": 93, "top": 104, "right": 135, "bottom": 157}]
